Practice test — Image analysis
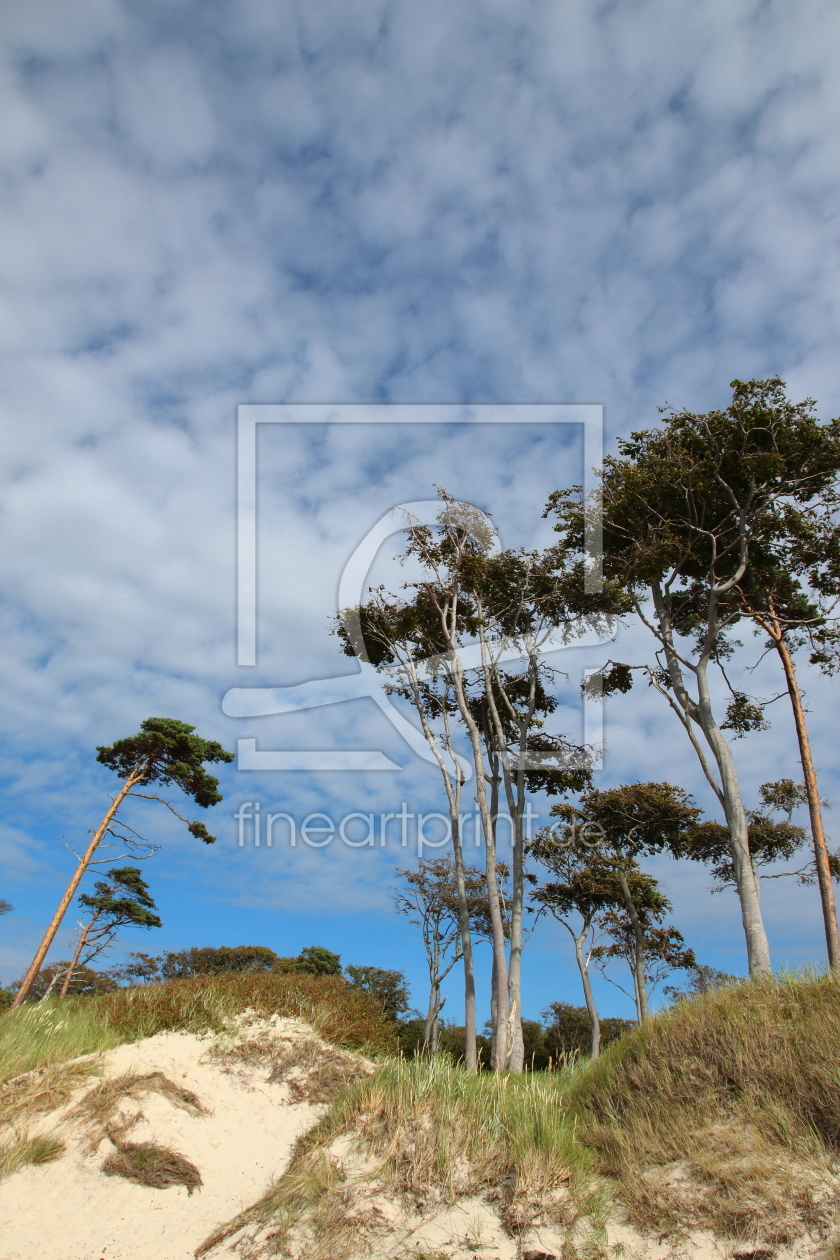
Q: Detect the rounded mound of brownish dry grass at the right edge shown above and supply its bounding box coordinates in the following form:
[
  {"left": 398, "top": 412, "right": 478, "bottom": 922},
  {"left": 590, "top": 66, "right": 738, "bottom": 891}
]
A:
[{"left": 567, "top": 977, "right": 840, "bottom": 1245}]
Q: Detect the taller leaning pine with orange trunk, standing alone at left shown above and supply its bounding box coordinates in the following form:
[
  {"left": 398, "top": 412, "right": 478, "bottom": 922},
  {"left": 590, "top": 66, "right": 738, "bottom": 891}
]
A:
[{"left": 14, "top": 717, "right": 234, "bottom": 1007}]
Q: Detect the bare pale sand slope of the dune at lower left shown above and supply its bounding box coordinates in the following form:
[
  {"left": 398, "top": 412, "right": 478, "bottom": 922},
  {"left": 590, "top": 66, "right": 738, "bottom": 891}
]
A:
[{"left": 0, "top": 1019, "right": 324, "bottom": 1260}]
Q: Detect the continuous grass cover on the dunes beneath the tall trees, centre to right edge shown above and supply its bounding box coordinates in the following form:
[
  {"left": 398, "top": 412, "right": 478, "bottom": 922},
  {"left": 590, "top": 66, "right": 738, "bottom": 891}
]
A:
[{"left": 203, "top": 975, "right": 840, "bottom": 1260}]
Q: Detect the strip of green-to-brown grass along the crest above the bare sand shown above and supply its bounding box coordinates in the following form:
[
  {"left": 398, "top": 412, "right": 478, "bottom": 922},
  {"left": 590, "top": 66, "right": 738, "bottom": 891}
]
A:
[{"left": 0, "top": 971, "right": 394, "bottom": 1081}]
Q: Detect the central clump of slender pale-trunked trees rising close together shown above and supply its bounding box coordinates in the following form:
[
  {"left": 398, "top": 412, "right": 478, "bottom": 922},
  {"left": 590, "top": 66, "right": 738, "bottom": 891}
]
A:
[{"left": 339, "top": 491, "right": 607, "bottom": 1071}]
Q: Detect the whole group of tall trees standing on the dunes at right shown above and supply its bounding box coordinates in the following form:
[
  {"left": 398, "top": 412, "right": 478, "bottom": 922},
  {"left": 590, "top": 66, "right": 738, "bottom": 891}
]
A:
[{"left": 334, "top": 378, "right": 840, "bottom": 1071}]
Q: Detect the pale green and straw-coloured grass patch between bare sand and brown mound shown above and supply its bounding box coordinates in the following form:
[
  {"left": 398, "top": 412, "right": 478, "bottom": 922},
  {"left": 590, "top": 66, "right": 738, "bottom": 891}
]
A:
[{"left": 196, "top": 1058, "right": 599, "bottom": 1260}]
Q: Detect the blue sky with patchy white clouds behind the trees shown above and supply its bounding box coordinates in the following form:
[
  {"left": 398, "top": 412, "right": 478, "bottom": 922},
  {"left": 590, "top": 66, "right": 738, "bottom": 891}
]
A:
[{"left": 0, "top": 0, "right": 840, "bottom": 1017}]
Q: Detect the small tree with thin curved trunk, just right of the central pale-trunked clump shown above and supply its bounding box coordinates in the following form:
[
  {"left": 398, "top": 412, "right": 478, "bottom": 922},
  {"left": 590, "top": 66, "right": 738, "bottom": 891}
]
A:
[{"left": 529, "top": 827, "right": 621, "bottom": 1058}]
